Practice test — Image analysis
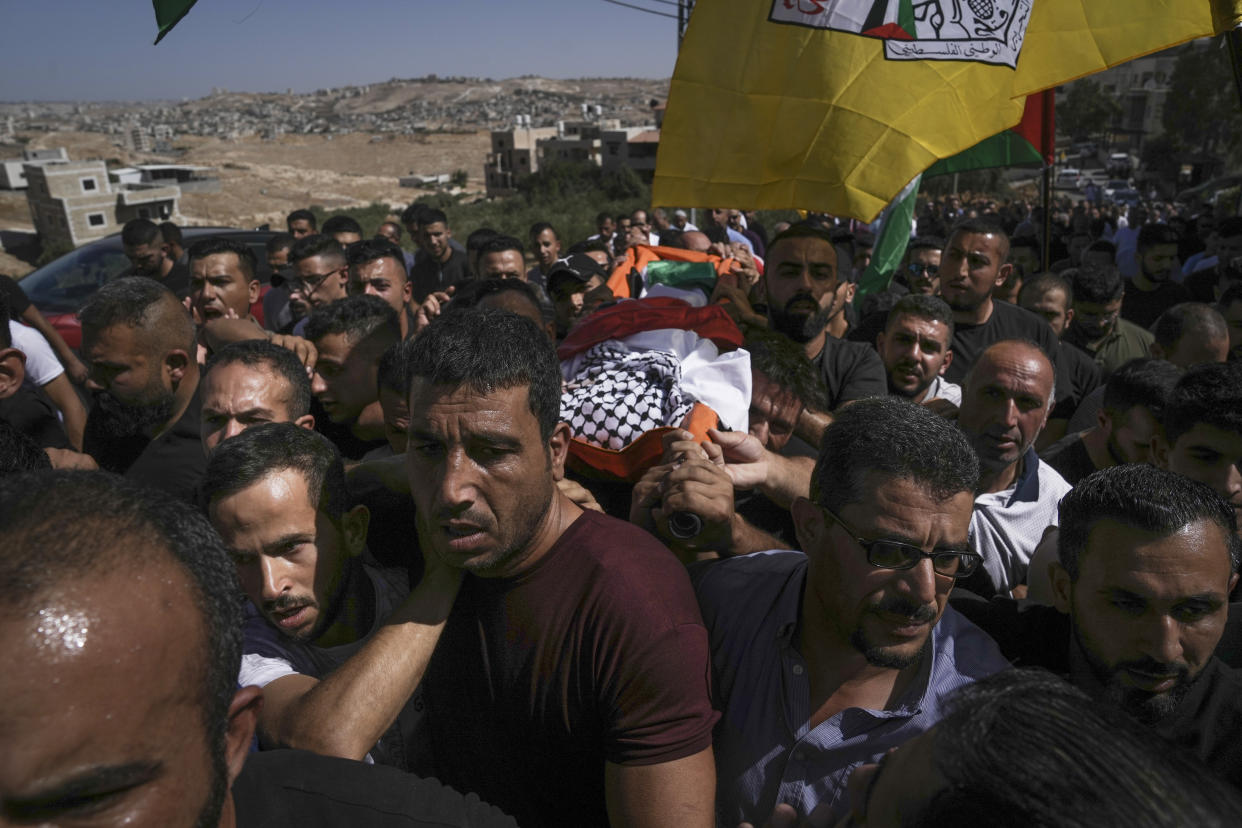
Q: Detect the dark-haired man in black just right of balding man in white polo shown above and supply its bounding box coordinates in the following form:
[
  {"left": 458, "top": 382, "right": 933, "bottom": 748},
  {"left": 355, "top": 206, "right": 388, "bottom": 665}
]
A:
[{"left": 1040, "top": 358, "right": 1181, "bottom": 485}]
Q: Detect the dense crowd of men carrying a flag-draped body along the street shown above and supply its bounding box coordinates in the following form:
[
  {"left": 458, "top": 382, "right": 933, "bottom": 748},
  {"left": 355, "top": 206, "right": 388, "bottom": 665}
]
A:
[{"left": 0, "top": 199, "right": 1242, "bottom": 828}]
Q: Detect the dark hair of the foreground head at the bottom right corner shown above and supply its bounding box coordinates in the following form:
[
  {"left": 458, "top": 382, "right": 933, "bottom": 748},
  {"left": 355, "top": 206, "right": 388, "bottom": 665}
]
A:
[{"left": 902, "top": 669, "right": 1240, "bottom": 828}]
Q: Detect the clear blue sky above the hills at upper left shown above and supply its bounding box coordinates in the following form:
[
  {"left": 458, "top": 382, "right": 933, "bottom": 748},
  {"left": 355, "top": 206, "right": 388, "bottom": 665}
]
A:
[{"left": 0, "top": 0, "right": 677, "bottom": 101}]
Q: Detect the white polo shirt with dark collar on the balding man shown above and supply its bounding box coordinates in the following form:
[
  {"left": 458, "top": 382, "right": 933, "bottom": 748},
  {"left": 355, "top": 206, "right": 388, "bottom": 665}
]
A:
[{"left": 970, "top": 448, "right": 1072, "bottom": 593}]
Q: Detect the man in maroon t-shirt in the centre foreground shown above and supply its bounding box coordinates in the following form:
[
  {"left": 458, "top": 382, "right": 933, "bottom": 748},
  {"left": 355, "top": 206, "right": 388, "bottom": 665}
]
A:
[{"left": 406, "top": 309, "right": 717, "bottom": 827}]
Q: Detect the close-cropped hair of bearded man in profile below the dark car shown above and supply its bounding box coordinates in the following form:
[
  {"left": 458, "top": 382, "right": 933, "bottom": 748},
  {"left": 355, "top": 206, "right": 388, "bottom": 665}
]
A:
[{"left": 78, "top": 276, "right": 195, "bottom": 354}]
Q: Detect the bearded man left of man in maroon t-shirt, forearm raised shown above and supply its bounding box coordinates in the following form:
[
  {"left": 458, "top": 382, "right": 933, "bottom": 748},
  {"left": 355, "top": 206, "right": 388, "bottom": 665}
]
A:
[{"left": 202, "top": 423, "right": 437, "bottom": 768}]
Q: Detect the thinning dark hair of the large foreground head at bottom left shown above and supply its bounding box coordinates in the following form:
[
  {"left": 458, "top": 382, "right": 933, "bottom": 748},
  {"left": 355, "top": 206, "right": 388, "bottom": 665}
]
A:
[{"left": 0, "top": 470, "right": 242, "bottom": 757}]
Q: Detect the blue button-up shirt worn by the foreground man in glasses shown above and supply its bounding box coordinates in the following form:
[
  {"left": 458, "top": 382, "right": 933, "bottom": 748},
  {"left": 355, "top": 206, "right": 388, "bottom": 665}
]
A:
[{"left": 691, "top": 551, "right": 1009, "bottom": 826}]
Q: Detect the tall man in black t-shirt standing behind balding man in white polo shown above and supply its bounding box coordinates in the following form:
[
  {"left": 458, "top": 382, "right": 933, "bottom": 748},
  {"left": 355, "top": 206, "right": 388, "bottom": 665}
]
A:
[{"left": 940, "top": 218, "right": 1057, "bottom": 385}]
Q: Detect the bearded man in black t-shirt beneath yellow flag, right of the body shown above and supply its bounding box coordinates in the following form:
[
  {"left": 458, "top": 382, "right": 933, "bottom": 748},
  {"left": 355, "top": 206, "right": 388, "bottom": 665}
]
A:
[{"left": 761, "top": 225, "right": 888, "bottom": 408}]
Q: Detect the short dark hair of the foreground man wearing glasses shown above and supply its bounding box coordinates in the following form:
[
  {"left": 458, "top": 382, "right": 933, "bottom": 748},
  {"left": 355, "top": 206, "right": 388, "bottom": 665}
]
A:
[{"left": 811, "top": 397, "right": 979, "bottom": 511}]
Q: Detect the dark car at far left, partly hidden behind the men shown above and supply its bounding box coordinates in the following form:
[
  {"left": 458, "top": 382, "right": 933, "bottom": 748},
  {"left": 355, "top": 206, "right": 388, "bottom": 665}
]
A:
[{"left": 20, "top": 227, "right": 276, "bottom": 348}]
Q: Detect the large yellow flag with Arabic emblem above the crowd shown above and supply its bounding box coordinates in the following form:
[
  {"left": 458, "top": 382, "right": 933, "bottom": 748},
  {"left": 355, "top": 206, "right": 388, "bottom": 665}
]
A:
[{"left": 653, "top": 0, "right": 1242, "bottom": 221}]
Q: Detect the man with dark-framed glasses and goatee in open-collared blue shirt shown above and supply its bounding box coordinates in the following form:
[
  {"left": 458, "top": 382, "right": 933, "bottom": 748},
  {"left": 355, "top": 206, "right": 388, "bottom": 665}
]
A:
[{"left": 691, "top": 397, "right": 1006, "bottom": 826}]
